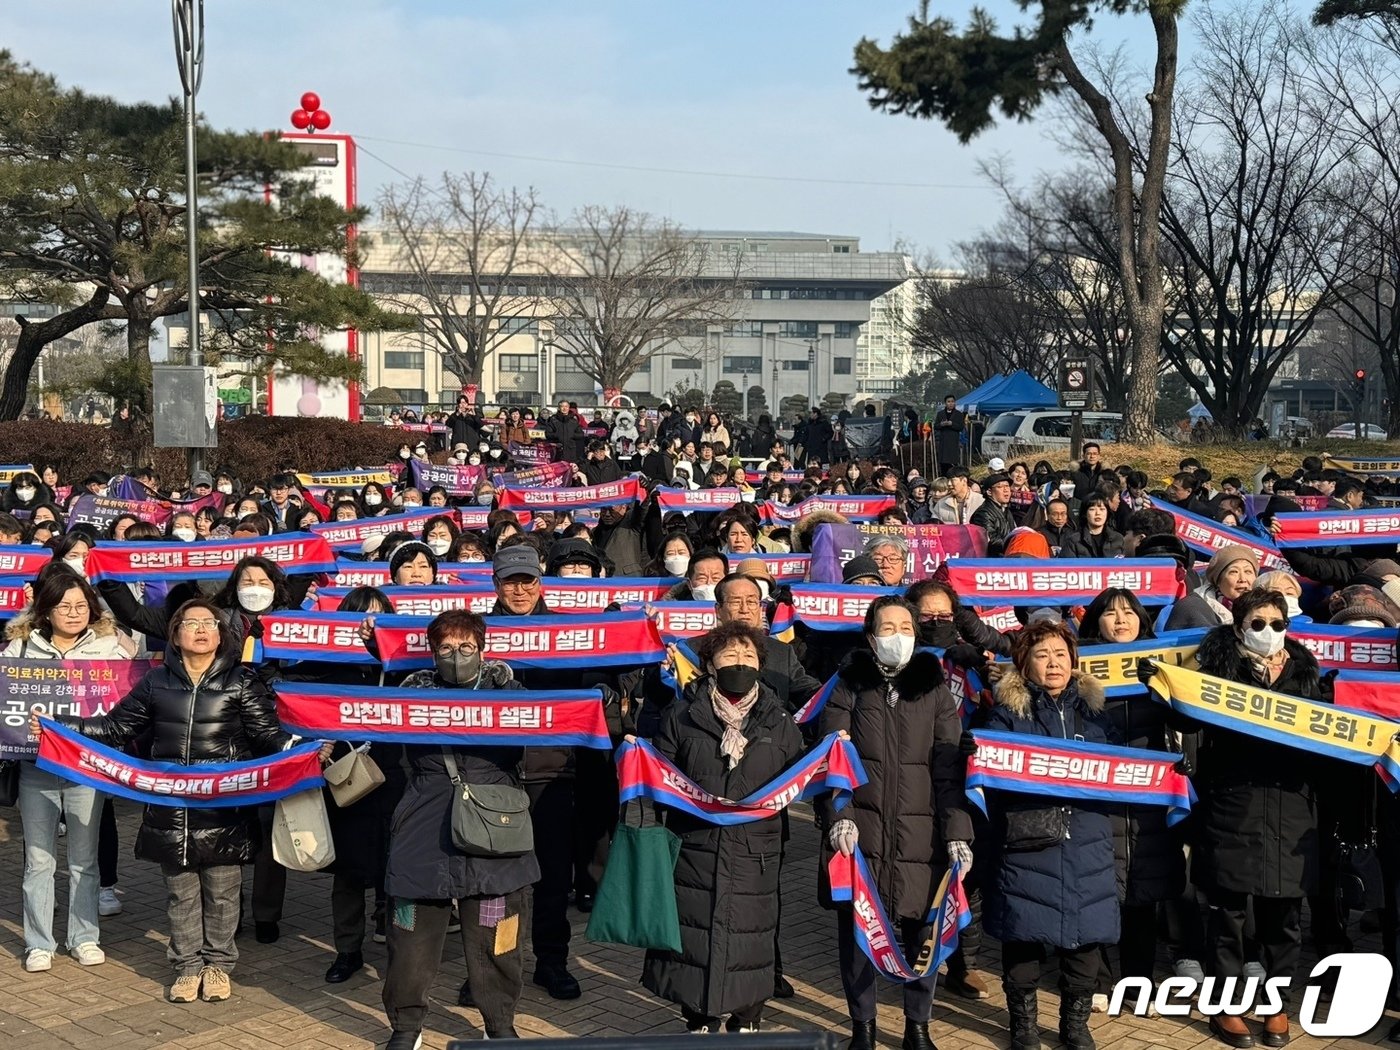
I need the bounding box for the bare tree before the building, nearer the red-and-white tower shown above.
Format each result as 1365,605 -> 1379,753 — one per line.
379,171 -> 539,386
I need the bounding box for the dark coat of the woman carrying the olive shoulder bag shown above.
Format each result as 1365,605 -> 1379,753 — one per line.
385,659 -> 539,900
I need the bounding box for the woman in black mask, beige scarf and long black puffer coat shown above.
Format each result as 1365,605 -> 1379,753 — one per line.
641,623 -> 802,1033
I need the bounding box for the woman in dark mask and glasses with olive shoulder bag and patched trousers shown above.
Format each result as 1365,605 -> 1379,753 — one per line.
384,613 -> 537,1050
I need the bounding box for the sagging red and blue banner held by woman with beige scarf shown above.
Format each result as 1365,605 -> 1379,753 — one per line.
616,732 -> 867,826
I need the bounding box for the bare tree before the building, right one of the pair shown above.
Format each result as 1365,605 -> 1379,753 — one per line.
540,206 -> 742,391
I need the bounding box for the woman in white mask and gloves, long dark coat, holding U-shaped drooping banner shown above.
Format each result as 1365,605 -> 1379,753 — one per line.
816,595 -> 973,1050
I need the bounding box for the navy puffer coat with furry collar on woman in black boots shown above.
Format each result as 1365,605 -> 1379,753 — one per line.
981,671 -> 1119,948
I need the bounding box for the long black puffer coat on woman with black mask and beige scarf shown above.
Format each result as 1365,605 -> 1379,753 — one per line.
641,675 -> 802,1016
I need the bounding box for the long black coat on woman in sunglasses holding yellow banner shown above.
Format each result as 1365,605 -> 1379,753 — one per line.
1191,624 -> 1327,897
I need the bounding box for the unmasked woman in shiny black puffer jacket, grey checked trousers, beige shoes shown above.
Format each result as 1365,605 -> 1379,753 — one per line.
47,598 -> 306,1002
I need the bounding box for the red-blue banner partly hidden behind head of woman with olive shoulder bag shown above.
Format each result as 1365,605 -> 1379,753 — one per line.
374,612 -> 666,671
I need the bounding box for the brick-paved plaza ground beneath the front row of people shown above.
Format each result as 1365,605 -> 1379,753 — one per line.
0,801 -> 1389,1050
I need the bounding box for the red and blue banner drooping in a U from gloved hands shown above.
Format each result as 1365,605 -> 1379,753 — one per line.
826,846 -> 972,983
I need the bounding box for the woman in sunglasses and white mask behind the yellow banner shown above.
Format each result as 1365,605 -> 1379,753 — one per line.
1191,589 -> 1331,1047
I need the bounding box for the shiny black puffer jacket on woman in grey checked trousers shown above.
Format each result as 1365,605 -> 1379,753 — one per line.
60,648 -> 291,868
